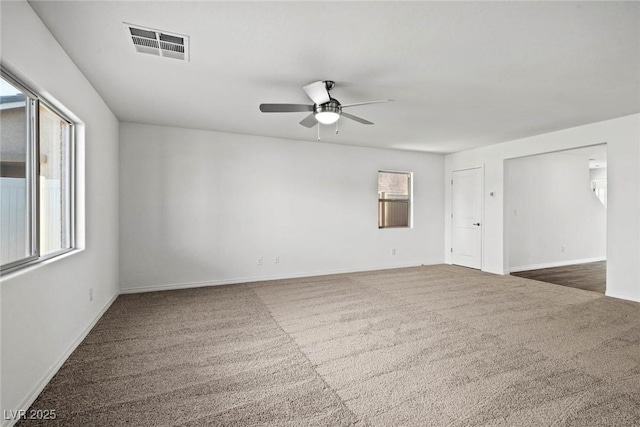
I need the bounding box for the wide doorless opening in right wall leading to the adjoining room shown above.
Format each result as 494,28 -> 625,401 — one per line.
505,144 -> 607,293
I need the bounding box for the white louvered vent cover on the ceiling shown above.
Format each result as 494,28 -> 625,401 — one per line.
124,22 -> 189,61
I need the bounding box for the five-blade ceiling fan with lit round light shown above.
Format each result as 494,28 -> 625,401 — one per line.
260,80 -> 393,128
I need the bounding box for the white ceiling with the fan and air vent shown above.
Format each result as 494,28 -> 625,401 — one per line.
30,1 -> 640,153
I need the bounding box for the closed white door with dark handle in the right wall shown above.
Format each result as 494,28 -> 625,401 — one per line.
451,168 -> 483,269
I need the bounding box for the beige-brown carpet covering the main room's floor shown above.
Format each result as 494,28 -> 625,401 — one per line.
21,266 -> 640,426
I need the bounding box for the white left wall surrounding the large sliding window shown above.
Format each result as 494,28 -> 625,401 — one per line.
0,1 -> 118,424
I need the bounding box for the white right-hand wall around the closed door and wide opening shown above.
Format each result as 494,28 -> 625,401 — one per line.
445,114 -> 640,300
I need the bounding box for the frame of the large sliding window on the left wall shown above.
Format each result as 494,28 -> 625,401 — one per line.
0,64 -> 77,276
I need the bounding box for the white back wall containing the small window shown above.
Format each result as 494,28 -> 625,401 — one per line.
120,123 -> 444,292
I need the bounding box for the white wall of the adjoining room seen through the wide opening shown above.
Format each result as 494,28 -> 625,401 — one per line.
505,151 -> 607,271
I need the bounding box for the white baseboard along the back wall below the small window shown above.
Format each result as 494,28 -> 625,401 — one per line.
120,260 -> 442,294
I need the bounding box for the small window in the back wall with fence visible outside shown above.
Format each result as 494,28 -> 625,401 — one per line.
378,171 -> 411,228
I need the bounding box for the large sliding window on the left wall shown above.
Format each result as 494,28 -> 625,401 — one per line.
0,70 -> 74,271
